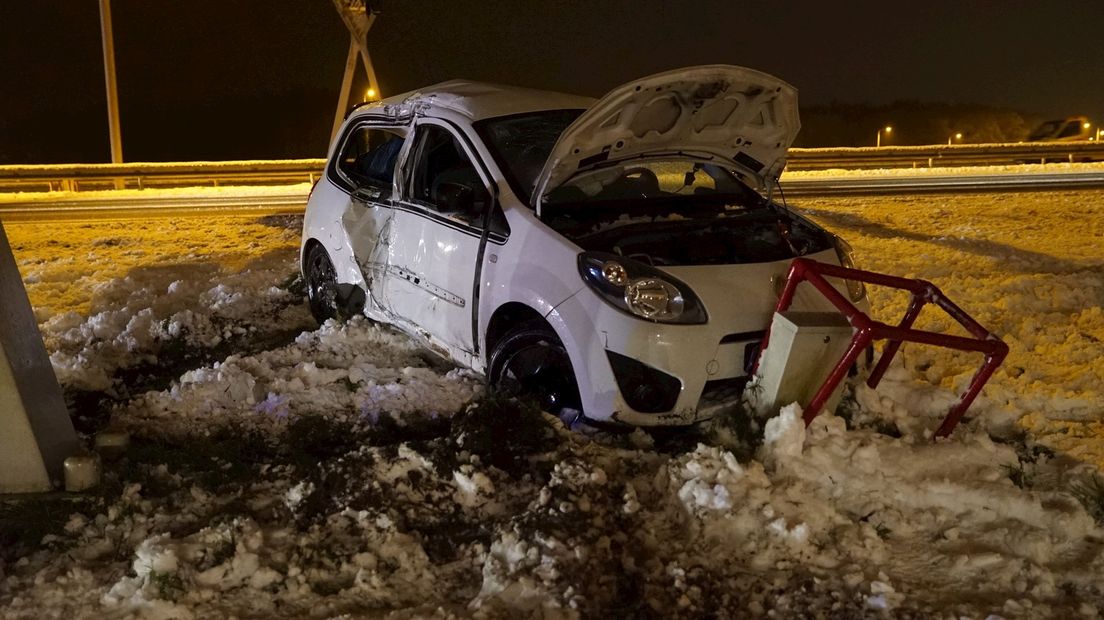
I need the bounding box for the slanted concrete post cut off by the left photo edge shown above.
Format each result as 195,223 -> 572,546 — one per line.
0,219 -> 81,493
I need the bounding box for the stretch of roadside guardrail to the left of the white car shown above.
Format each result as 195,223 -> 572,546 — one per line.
0,159 -> 326,192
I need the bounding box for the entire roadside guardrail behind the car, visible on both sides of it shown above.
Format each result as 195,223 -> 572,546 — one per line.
0,142 -> 1104,192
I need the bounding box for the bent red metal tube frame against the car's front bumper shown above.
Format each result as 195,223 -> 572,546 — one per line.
762,258 -> 1008,437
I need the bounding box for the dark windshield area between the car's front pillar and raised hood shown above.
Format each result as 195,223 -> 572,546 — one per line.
474,109 -> 584,204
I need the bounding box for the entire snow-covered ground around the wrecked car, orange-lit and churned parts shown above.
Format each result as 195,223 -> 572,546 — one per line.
0,185 -> 1104,619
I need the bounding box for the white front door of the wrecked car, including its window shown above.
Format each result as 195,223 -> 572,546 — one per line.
384,118 -> 493,361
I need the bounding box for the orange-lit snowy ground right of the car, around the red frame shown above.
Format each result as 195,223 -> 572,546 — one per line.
795,191 -> 1104,467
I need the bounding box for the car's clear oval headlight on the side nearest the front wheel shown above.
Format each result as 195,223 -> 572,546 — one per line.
578,252 -> 709,324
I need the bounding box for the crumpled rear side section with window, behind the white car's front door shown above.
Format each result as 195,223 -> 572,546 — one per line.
329,117 -> 408,312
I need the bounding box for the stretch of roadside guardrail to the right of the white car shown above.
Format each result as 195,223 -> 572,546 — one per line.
786,142 -> 1104,170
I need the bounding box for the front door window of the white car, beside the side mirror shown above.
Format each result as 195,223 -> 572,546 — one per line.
410,125 -> 491,226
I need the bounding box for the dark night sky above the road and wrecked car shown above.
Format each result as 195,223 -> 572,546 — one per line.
0,0 -> 1104,163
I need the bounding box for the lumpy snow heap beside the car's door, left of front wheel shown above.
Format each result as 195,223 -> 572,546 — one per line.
115,319 -> 482,435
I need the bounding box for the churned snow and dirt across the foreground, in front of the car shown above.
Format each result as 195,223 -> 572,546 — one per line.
0,407 -> 1104,618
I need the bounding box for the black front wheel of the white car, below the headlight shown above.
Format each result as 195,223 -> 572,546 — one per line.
487,321 -> 582,416
